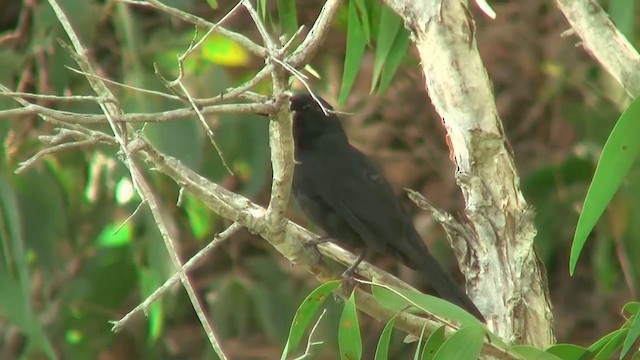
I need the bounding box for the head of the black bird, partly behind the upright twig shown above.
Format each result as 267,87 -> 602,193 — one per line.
291,94 -> 347,149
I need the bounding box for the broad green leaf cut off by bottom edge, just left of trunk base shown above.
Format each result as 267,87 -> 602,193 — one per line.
433,325 -> 485,360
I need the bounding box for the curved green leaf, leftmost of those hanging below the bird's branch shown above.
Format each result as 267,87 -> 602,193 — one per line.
280,280 -> 341,360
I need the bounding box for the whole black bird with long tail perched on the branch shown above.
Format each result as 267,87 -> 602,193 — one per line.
291,94 -> 484,321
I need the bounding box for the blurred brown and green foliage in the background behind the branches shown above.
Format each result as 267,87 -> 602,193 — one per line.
0,0 -> 640,359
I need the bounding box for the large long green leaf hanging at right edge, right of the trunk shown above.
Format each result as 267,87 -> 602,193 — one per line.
569,98 -> 640,275
